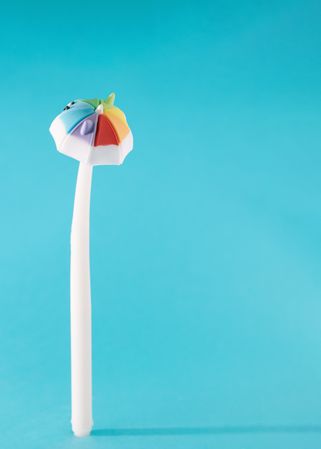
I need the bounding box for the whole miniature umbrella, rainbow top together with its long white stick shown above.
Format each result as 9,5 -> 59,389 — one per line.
49,94 -> 133,437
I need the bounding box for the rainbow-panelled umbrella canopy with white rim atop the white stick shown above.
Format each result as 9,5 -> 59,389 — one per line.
50,94 -> 133,165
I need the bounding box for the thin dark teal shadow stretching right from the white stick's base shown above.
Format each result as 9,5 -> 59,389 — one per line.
91,425 -> 321,437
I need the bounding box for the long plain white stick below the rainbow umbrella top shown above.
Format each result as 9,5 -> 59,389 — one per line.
70,162 -> 93,437
